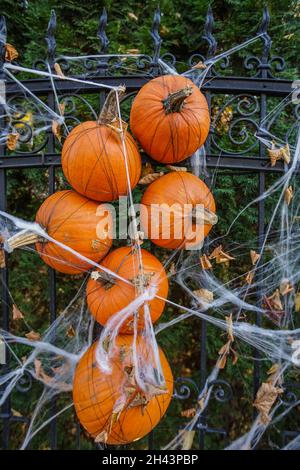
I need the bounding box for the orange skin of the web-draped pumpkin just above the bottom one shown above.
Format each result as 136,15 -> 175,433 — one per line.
86,247 -> 169,334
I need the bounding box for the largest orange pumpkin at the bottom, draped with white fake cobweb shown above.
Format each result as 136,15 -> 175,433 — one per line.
73,335 -> 173,445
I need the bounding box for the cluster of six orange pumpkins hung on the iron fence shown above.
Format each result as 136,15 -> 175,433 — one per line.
9,75 -> 215,444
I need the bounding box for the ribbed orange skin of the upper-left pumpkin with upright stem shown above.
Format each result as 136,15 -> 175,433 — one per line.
62,121 -> 141,202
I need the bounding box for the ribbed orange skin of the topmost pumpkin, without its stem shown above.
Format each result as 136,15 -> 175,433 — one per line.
130,75 -> 210,163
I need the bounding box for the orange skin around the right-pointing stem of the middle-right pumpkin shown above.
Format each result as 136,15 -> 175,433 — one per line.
141,171 -> 216,249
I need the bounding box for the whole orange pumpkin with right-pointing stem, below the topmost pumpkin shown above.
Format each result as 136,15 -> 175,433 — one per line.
141,171 -> 217,249
